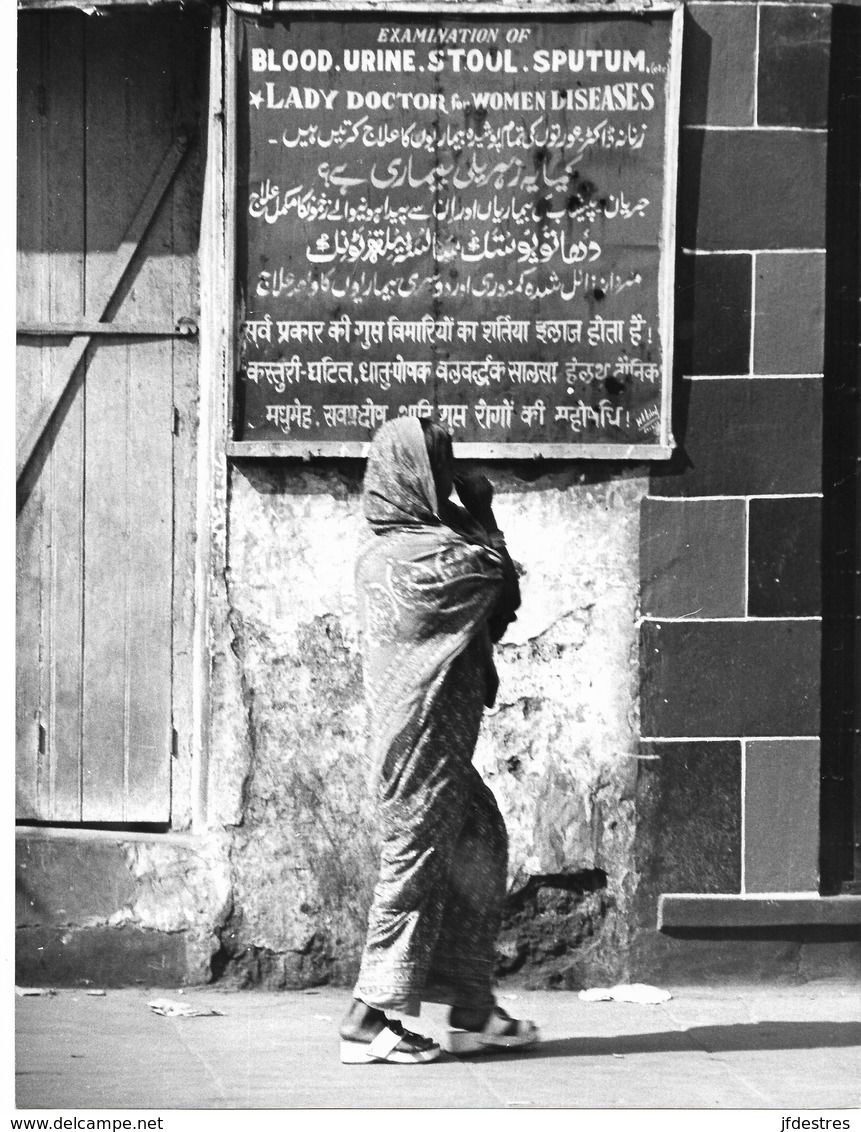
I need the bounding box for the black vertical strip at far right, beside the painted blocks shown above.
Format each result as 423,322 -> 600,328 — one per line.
820,5 -> 861,893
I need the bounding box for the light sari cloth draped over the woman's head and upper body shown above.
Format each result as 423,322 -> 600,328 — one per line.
356,417 -> 503,784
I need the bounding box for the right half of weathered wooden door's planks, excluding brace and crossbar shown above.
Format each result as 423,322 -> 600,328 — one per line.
84,16 -> 173,822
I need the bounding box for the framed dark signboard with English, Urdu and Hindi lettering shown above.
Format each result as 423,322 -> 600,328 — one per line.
230,5 -> 679,460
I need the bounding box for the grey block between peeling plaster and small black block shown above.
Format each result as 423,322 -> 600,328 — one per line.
640,498 -> 744,617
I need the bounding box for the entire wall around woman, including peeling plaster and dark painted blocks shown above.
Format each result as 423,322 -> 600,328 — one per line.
18,0 -> 861,987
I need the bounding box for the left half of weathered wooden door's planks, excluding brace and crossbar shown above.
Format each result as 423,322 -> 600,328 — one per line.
17,12 -> 84,821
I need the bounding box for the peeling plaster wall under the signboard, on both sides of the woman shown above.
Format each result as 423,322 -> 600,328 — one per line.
210,462 -> 647,986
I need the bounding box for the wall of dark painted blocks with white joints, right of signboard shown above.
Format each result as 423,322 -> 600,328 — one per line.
635,2 -> 859,975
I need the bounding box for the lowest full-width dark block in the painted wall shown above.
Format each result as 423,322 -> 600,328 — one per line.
640,621 -> 820,738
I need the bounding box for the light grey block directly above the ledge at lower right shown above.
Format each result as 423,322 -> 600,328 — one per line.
744,739 -> 819,899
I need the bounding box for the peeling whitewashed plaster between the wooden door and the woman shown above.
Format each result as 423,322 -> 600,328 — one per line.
212,464 -> 373,985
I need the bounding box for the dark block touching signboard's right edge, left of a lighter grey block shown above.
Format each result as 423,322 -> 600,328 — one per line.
675,255 -> 752,376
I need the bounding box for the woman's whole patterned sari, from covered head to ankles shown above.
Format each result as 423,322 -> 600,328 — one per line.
355,418 -> 516,1014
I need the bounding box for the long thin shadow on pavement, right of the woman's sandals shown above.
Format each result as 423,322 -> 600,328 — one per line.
459,1022 -> 861,1062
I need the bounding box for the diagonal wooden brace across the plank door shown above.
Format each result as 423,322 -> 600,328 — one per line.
16,137 -> 190,482
